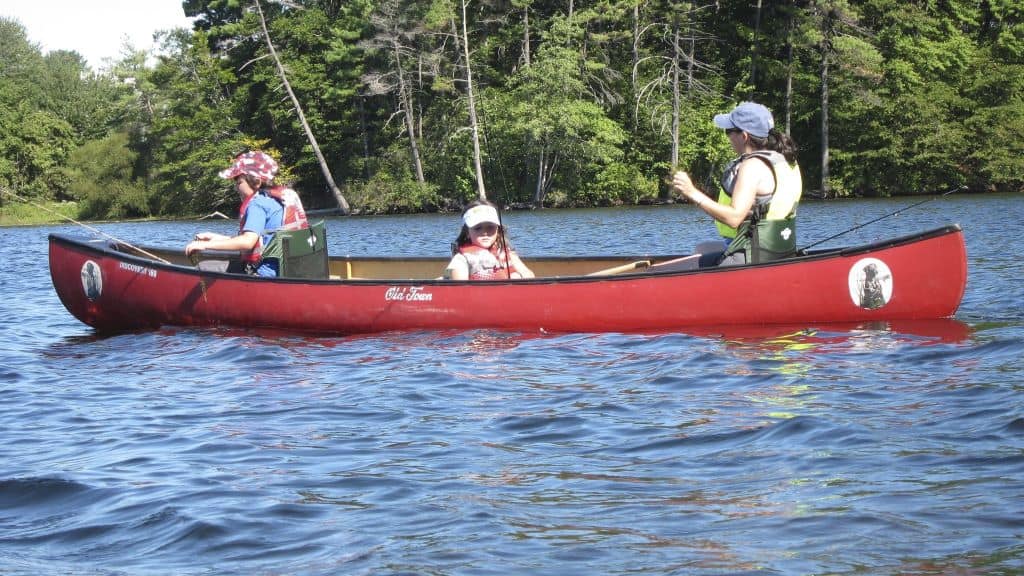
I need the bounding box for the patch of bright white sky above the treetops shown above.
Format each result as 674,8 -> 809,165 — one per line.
0,0 -> 190,71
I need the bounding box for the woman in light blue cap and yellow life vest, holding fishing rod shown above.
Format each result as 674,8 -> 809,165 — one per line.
672,102 -> 803,268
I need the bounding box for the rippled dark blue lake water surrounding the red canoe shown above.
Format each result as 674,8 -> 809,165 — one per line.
0,196 -> 1024,576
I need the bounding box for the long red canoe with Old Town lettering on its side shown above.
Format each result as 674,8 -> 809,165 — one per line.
49,224 -> 967,334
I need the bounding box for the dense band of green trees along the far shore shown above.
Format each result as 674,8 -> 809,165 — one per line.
0,0 -> 1024,217
